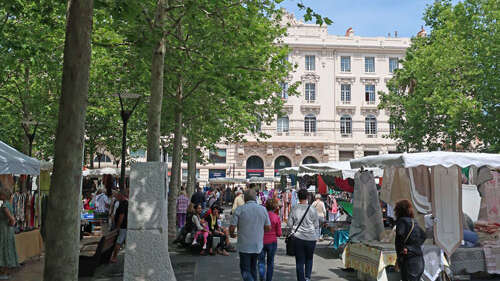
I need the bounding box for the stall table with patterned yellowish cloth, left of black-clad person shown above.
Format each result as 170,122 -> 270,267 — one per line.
343,241 -> 397,281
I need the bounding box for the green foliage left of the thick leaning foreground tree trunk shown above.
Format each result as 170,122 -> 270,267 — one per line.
0,1 -> 66,158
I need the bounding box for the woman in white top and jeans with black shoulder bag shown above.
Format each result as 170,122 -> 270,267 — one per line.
287,189 -> 319,281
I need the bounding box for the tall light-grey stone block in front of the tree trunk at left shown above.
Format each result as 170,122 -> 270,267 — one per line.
123,162 -> 176,281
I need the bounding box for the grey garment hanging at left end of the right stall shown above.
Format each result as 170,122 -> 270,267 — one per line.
349,171 -> 384,242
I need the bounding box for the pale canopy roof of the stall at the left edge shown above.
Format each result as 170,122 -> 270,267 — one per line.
0,141 -> 40,176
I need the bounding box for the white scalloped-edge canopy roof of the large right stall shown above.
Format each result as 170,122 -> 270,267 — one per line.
351,151 -> 500,168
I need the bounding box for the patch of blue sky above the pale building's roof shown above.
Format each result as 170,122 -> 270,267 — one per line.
281,0 -> 444,37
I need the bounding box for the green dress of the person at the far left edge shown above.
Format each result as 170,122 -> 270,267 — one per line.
0,201 -> 19,267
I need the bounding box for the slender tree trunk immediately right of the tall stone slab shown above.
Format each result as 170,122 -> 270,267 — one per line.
168,79 -> 183,235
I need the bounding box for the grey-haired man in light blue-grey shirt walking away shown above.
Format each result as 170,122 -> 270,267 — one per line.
229,189 -> 271,281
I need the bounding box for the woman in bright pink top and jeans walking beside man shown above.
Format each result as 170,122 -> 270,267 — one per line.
258,199 -> 281,281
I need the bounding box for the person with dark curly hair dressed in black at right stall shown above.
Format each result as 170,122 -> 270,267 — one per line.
394,200 -> 426,281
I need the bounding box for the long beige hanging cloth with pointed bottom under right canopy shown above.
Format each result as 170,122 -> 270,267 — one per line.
432,166 -> 463,256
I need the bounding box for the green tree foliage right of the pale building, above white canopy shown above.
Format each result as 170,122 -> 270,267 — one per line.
380,0 -> 500,152
